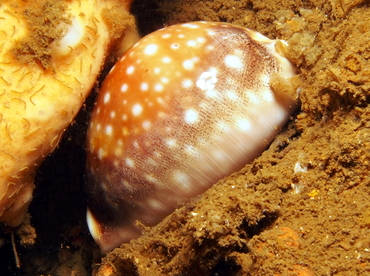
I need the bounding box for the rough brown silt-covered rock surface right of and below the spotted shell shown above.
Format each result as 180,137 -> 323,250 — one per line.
98,1 -> 370,275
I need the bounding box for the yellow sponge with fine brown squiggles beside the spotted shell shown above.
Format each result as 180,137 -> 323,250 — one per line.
0,0 -> 135,226
